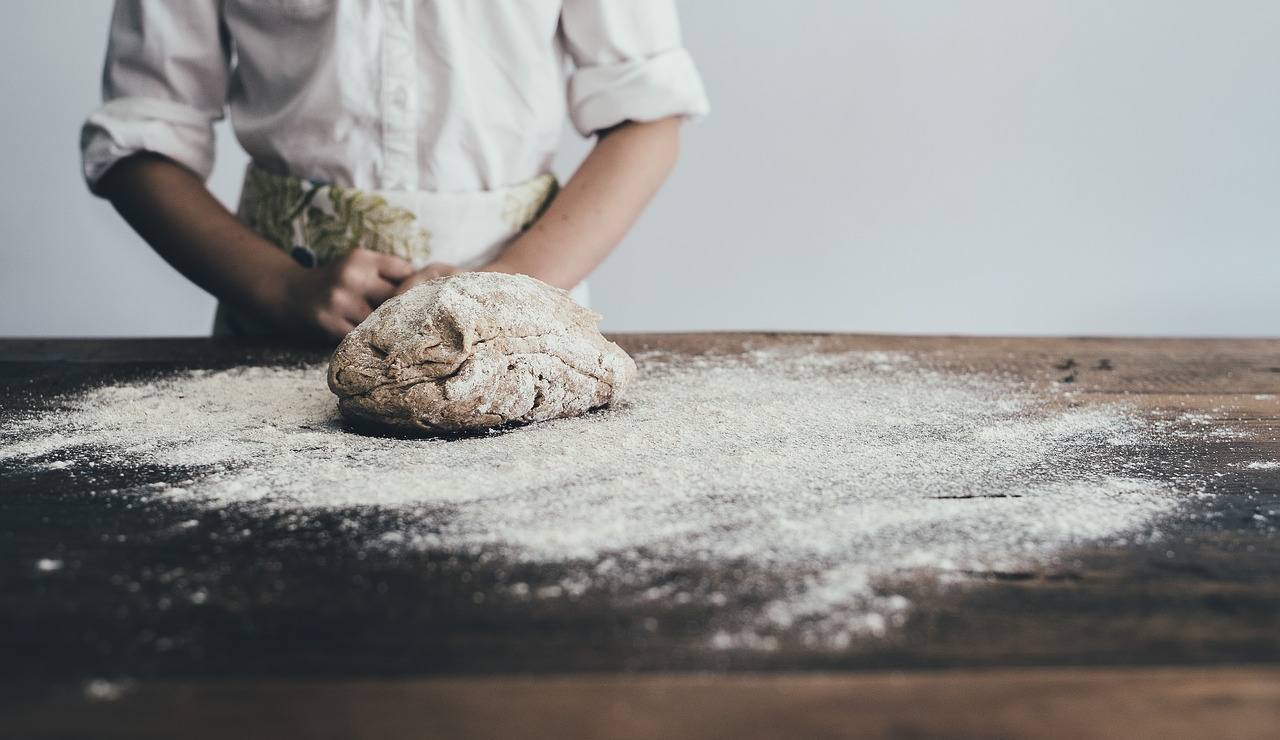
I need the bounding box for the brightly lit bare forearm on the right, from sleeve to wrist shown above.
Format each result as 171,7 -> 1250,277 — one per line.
485,118 -> 681,289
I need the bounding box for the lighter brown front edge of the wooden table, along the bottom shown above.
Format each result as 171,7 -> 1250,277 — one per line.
8,668 -> 1280,740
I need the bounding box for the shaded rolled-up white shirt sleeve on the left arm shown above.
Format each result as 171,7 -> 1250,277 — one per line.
81,0 -> 230,191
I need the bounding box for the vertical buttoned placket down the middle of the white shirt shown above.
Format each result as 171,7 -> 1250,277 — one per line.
381,0 -> 417,189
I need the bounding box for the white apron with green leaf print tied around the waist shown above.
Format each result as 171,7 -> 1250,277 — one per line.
214,164 -> 588,337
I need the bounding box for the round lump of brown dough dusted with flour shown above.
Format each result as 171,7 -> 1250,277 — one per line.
329,273 -> 636,431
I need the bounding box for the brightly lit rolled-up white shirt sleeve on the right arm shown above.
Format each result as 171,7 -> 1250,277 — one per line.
561,0 -> 709,136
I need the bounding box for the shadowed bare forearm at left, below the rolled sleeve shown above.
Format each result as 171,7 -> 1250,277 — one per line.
99,154 -> 300,314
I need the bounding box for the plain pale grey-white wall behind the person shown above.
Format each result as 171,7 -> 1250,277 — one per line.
0,0 -> 1280,335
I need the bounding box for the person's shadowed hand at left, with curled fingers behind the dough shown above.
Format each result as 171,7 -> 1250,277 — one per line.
264,248 -> 413,339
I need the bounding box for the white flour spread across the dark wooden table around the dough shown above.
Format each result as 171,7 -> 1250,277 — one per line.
0,351 -> 1179,649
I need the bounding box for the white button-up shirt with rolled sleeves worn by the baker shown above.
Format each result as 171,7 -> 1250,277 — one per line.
81,0 -> 708,192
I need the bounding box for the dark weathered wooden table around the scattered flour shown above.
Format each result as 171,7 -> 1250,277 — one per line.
0,334 -> 1280,739
